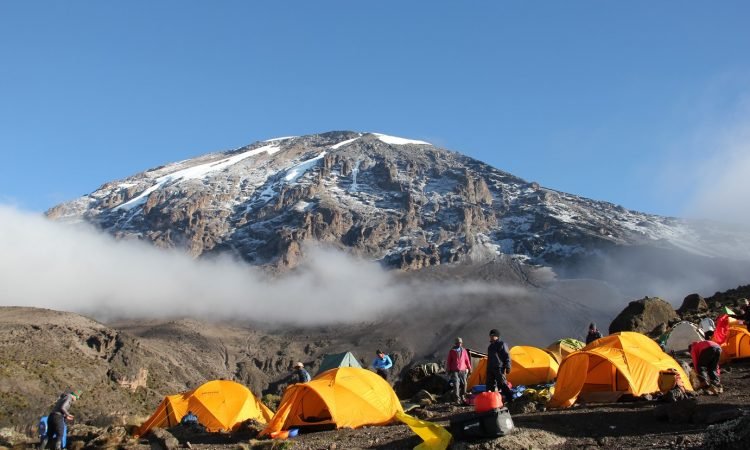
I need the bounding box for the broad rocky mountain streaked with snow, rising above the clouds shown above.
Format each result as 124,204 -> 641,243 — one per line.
47,131 -> 750,269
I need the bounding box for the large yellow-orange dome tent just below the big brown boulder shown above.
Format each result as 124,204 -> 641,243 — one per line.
548,331 -> 693,408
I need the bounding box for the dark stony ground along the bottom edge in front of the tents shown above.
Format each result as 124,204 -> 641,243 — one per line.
0,361 -> 750,450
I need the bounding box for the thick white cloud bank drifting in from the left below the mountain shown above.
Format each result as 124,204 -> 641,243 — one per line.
0,206 -> 525,325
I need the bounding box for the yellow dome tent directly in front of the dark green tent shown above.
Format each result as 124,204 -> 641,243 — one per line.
262,367 -> 404,435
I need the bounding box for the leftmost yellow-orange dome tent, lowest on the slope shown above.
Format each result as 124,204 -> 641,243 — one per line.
136,380 -> 273,436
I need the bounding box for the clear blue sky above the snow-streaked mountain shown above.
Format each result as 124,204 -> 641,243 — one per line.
0,0 -> 750,215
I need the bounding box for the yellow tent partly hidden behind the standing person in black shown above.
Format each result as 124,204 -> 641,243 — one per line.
466,345 -> 558,388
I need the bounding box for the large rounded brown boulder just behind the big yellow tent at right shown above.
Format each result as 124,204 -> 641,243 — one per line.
609,297 -> 680,334
